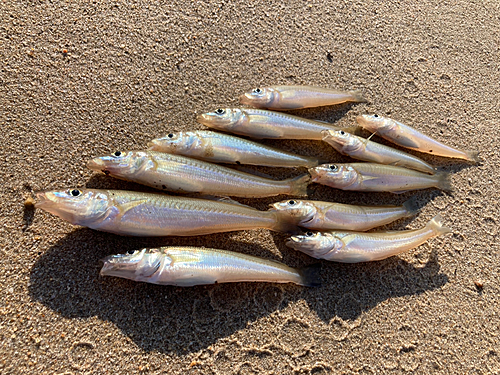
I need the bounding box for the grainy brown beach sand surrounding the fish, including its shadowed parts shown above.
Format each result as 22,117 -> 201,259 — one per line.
0,0 -> 500,374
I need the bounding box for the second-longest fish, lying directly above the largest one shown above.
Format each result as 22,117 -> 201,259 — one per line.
87,151 -> 311,198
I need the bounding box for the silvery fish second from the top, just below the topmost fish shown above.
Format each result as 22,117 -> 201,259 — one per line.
197,108 -> 353,140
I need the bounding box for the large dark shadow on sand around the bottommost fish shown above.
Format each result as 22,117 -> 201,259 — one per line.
29,229 -> 448,354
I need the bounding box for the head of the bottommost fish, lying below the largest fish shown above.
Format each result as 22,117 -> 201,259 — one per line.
101,248 -> 164,281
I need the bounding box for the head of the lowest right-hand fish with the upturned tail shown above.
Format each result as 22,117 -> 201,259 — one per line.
286,231 -> 344,259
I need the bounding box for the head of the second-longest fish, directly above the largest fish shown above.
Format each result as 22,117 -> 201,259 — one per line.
87,151 -> 150,177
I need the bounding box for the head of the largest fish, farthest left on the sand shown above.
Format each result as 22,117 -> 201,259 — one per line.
35,189 -> 110,225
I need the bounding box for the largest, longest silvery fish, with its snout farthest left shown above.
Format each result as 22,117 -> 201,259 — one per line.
35,189 -> 296,237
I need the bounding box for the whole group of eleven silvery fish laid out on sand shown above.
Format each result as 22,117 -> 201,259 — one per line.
36,86 -> 478,286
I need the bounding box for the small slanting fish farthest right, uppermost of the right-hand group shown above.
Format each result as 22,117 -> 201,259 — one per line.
356,115 -> 480,162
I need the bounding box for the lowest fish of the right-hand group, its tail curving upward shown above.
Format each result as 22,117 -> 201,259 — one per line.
286,215 -> 451,263
